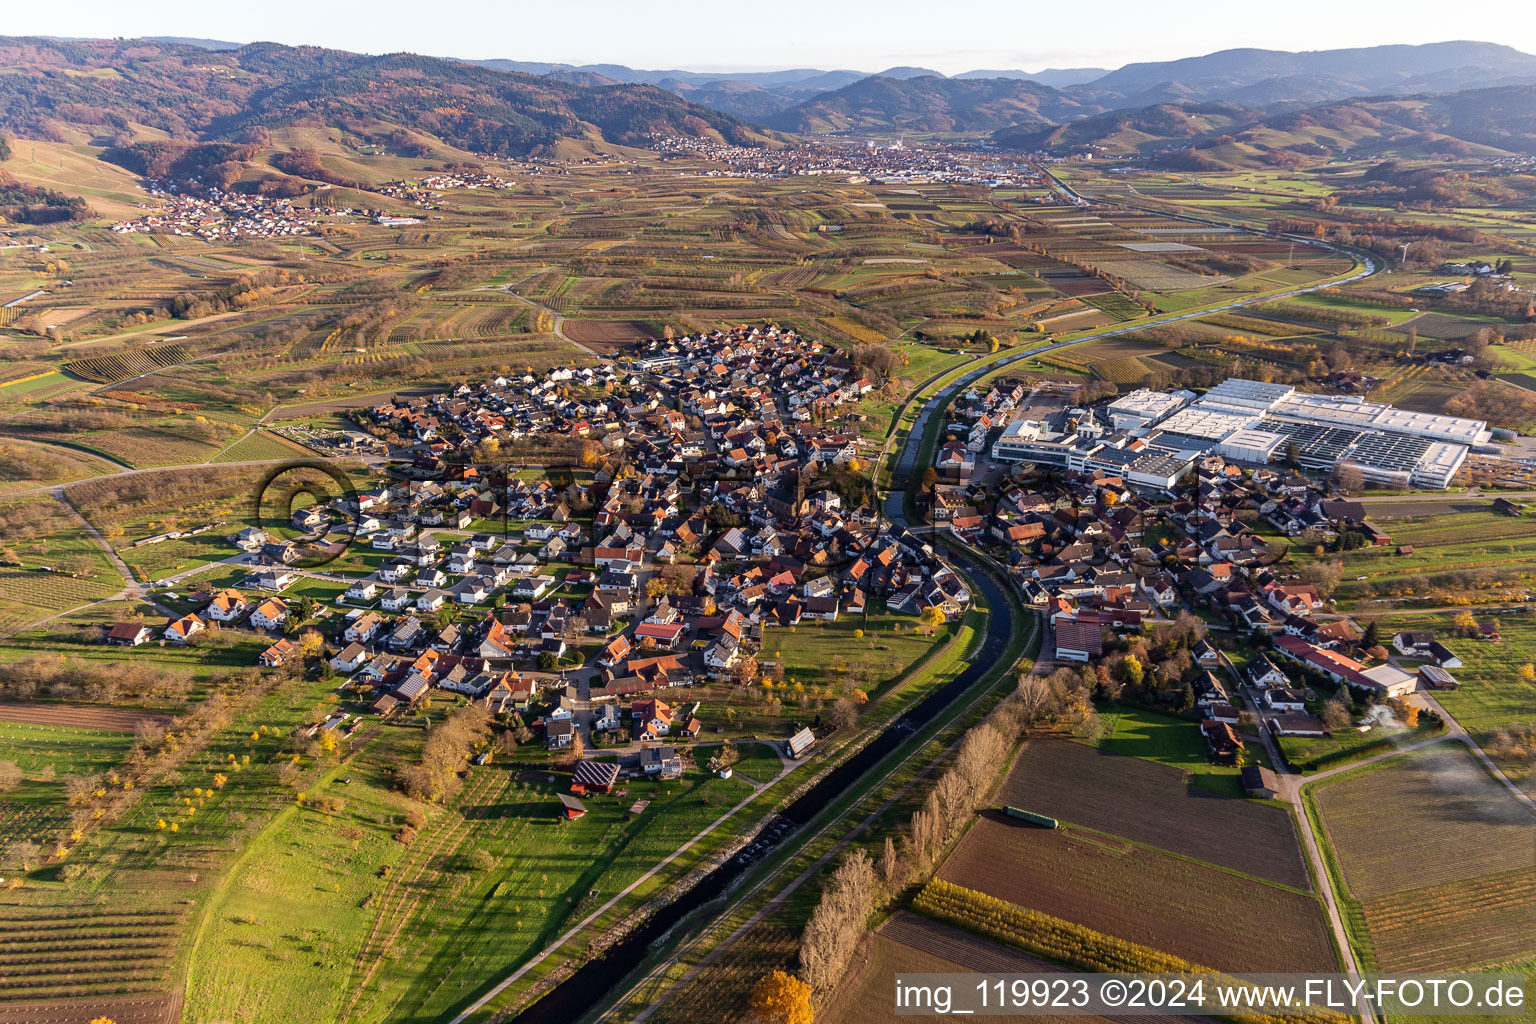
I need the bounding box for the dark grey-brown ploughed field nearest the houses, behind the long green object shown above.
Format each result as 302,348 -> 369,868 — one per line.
998,738 -> 1310,889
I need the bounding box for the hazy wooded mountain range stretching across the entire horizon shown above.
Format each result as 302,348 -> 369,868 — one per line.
0,37 -> 1536,169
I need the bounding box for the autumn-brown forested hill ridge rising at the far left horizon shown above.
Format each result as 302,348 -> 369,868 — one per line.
0,37 -> 762,155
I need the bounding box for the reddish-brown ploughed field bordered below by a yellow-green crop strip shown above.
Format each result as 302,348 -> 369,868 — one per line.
938,812 -> 1335,972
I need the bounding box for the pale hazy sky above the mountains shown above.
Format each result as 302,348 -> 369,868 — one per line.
21,0 -> 1536,74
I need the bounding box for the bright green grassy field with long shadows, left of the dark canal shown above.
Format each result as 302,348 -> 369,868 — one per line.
187,726 -> 768,1019
